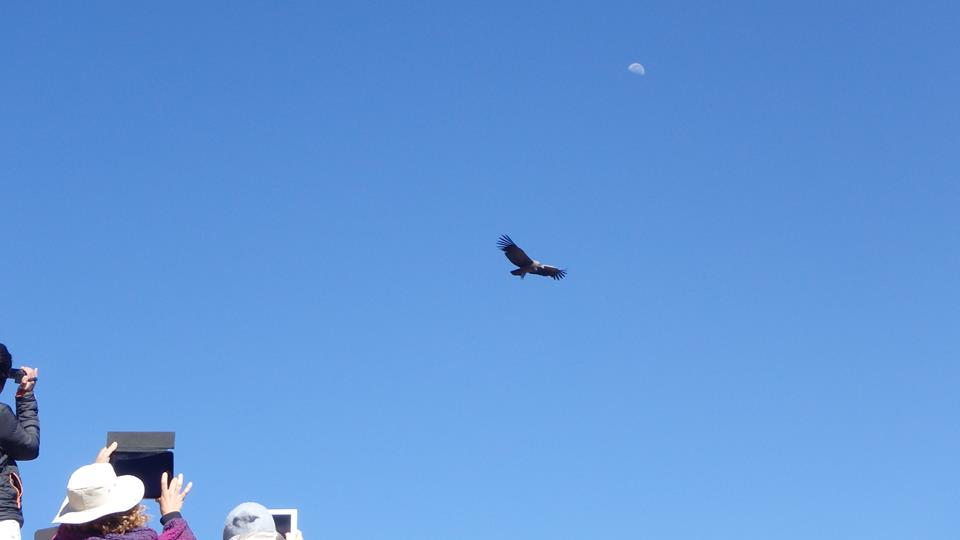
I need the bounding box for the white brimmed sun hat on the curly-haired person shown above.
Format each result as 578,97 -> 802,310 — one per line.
53,463 -> 143,524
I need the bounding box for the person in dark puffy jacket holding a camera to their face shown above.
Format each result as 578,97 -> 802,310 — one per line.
0,343 -> 40,540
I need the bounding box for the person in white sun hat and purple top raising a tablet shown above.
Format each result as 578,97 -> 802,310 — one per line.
53,443 -> 196,540
